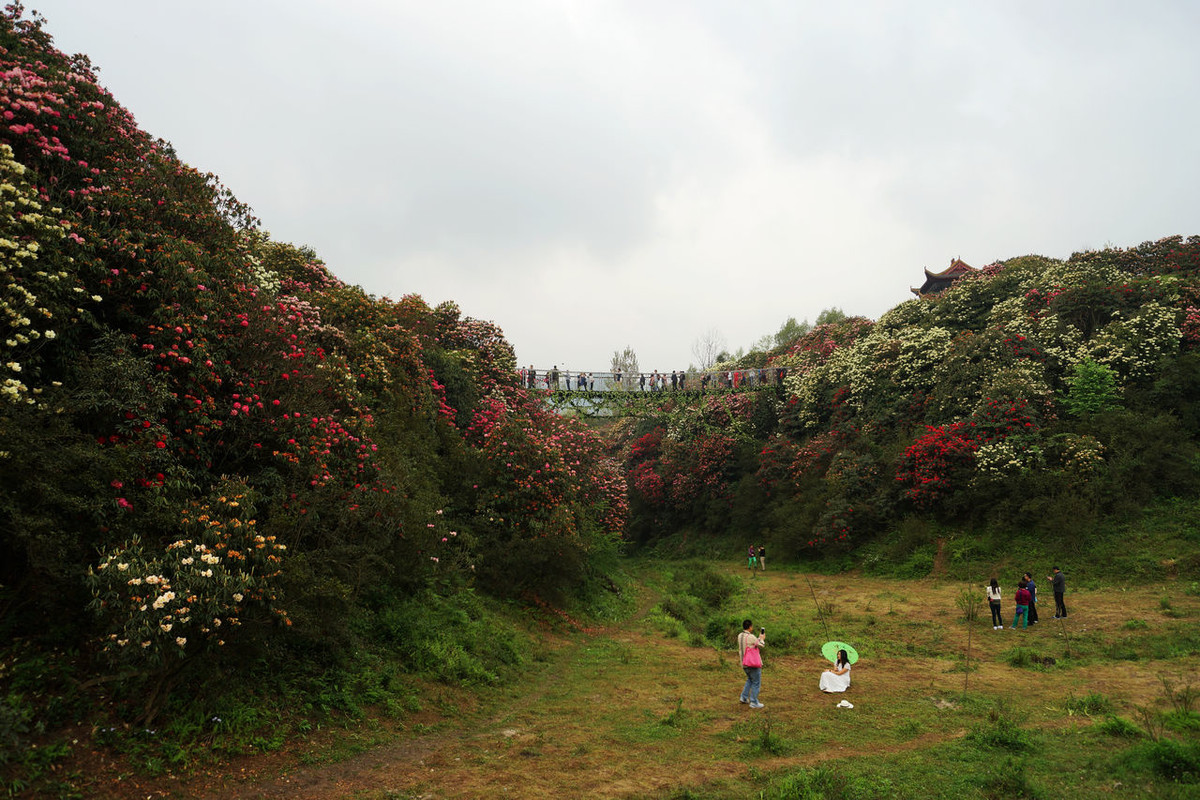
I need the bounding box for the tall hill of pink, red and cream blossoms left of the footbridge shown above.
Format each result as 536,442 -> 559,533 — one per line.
0,5 -> 625,709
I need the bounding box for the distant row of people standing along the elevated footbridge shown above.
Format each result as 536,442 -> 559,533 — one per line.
518,365 -> 787,392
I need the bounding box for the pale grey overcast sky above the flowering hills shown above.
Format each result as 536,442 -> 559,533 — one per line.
26,0 -> 1200,372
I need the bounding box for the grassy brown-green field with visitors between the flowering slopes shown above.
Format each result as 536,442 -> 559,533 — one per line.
114,561 -> 1200,800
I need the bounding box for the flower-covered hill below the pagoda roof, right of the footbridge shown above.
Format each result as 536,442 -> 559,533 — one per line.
626,236 -> 1200,575
